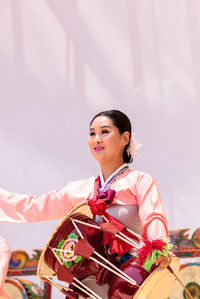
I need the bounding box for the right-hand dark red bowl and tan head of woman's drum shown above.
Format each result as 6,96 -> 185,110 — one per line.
108,257 -> 179,299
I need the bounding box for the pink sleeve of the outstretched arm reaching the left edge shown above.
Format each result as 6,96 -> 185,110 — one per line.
0,182 -> 88,223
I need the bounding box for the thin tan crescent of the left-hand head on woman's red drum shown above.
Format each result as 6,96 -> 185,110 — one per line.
37,202 -> 93,280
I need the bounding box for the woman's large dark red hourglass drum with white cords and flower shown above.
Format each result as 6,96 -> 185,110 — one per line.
37,203 -> 179,299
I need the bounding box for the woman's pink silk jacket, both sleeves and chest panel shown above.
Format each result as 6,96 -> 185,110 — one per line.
0,170 -> 168,239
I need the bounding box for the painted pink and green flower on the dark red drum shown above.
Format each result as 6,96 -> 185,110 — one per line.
56,233 -> 83,268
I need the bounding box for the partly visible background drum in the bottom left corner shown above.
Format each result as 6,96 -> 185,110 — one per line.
3,278 -> 45,299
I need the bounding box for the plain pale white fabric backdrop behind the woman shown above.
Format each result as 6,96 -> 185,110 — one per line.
0,0 -> 200,298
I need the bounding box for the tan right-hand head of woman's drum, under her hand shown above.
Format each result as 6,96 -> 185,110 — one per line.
134,257 -> 181,299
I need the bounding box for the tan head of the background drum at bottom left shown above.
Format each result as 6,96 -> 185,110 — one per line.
3,278 -> 28,299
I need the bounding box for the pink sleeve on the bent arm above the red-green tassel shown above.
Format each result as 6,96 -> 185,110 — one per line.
136,173 -> 169,240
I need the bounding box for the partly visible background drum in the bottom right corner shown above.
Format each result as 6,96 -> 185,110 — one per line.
169,259 -> 200,299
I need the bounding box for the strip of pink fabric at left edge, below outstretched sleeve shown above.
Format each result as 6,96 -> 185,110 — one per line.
0,236 -> 11,299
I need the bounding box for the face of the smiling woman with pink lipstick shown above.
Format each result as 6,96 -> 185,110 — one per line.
88,116 -> 129,163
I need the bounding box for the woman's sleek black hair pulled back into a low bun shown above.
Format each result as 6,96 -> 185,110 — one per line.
90,110 -> 133,163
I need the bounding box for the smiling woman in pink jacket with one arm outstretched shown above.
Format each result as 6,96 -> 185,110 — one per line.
0,110 -> 171,296
